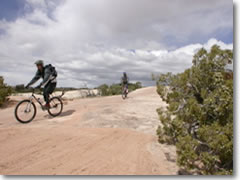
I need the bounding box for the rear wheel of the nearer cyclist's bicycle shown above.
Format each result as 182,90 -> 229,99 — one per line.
48,97 -> 63,117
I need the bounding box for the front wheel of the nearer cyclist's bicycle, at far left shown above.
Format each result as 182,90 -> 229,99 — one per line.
14,100 -> 37,123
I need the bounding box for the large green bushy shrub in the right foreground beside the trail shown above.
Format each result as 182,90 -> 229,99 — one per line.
157,45 -> 233,175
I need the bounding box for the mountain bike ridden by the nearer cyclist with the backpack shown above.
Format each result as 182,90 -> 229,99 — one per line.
15,89 -> 64,123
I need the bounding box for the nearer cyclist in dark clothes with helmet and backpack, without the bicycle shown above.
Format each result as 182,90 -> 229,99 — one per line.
26,60 -> 57,109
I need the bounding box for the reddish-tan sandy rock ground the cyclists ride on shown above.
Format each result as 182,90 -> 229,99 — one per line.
0,87 -> 178,175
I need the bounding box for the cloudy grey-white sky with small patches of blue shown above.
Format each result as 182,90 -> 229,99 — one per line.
0,0 -> 233,87
